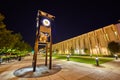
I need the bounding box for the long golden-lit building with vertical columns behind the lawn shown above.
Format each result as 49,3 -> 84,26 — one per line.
53,23 -> 120,55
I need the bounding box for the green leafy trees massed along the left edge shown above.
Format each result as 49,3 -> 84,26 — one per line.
0,13 -> 32,55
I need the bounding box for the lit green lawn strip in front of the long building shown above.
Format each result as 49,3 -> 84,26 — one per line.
53,55 -> 113,64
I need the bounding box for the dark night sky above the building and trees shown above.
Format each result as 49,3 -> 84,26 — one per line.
0,0 -> 120,46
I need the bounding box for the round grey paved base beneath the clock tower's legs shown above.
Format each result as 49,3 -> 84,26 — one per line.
14,64 -> 61,78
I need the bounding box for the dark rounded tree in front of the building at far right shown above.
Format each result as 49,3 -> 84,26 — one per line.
108,41 -> 120,54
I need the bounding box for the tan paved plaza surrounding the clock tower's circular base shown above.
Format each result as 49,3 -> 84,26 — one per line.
0,56 -> 120,80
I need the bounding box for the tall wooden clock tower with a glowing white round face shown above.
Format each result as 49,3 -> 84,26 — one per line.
32,10 -> 55,72
